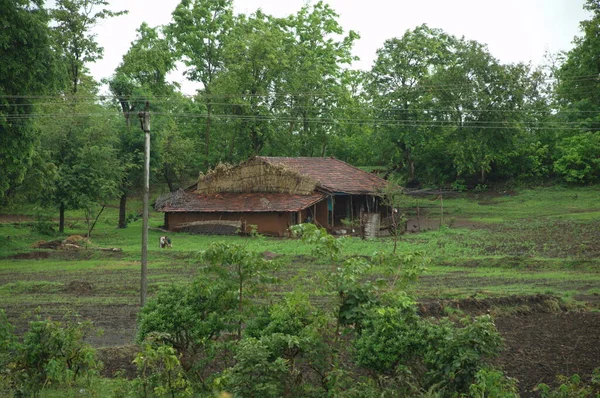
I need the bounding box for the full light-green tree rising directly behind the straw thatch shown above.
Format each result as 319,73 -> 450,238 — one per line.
213,10 -> 289,162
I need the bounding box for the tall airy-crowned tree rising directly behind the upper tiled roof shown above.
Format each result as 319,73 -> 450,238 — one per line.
279,1 -> 359,156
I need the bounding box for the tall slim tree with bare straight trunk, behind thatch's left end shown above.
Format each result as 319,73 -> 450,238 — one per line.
167,0 -> 233,168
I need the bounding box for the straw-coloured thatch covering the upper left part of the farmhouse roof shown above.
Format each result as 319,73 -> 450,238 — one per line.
196,158 -> 317,195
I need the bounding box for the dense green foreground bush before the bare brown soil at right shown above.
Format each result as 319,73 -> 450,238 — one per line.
354,304 -> 501,393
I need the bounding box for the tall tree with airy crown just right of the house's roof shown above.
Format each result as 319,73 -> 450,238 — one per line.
369,25 -> 456,181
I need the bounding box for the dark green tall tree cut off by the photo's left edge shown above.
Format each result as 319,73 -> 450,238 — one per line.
0,0 -> 60,201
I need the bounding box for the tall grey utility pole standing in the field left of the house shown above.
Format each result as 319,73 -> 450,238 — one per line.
138,101 -> 150,307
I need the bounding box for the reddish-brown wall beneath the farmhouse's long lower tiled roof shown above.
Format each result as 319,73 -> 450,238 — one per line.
165,212 -> 291,236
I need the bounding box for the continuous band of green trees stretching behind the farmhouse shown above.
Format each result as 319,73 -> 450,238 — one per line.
0,0 -> 600,230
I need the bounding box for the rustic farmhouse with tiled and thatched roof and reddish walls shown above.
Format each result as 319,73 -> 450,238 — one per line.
155,156 -> 388,236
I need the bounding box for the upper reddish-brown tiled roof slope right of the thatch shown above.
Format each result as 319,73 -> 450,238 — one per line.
259,156 -> 387,195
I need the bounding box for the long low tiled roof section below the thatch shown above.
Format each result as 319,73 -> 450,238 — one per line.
156,191 -> 326,213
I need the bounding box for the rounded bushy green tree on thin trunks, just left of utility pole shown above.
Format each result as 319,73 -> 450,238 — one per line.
38,91 -> 123,233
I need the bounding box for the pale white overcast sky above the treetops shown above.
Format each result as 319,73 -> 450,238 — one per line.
89,0 -> 590,94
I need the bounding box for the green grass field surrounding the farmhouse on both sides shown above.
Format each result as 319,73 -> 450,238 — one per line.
0,187 -> 600,320
